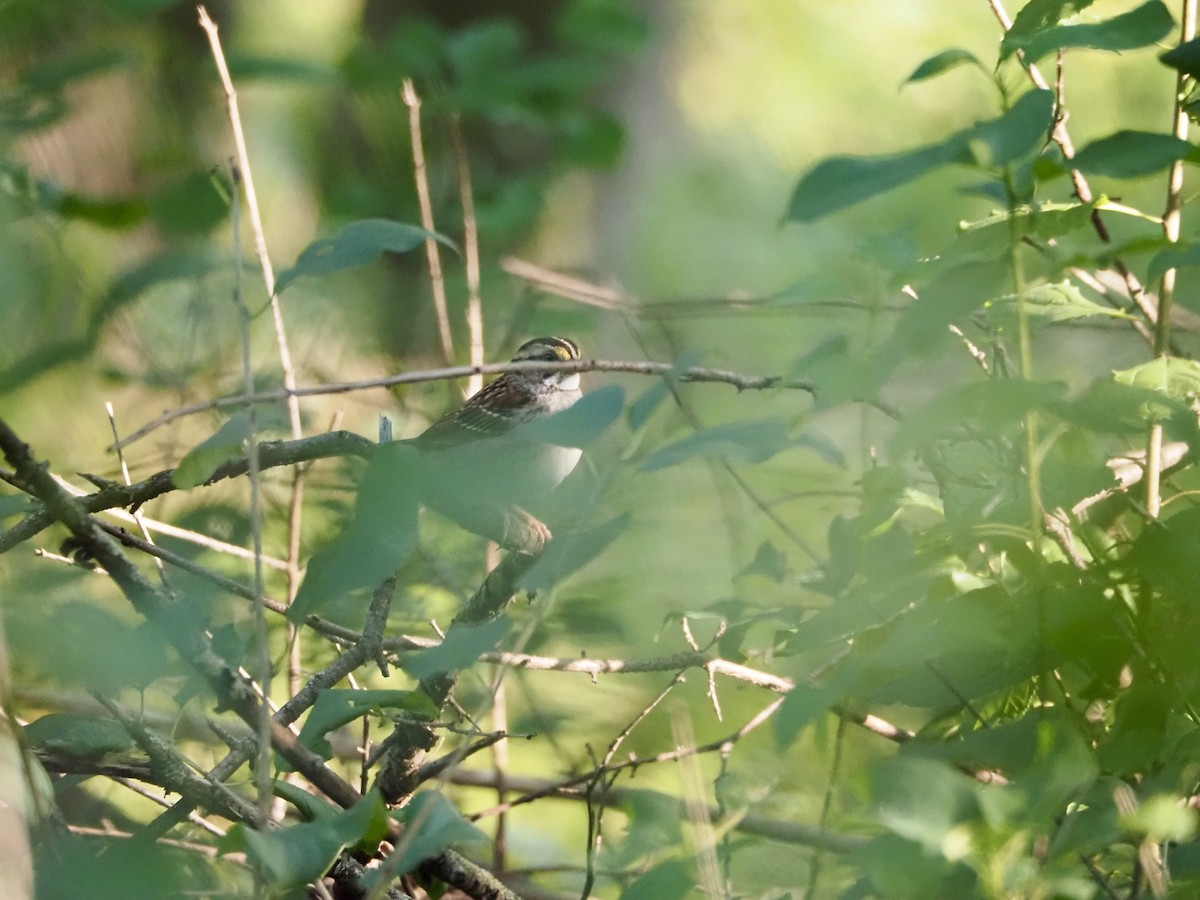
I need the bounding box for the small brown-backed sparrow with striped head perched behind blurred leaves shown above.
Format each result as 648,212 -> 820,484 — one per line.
412,337 -> 582,553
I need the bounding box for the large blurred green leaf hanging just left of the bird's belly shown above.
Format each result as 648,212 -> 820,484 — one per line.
288,442 -> 419,622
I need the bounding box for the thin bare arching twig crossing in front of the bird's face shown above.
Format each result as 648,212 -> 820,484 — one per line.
112,360 -> 816,446
